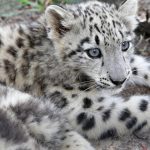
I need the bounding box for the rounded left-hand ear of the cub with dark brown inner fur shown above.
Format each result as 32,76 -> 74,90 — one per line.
45,5 -> 74,37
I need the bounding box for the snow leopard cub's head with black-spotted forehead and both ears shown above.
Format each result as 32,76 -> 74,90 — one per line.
45,0 -> 138,92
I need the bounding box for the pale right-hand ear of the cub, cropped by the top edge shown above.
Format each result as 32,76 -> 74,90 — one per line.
119,0 -> 138,30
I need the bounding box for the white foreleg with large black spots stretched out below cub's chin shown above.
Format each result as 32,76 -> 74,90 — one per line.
68,95 -> 150,140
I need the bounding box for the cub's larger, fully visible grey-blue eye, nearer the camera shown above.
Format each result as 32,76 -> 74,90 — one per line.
86,48 -> 102,59
